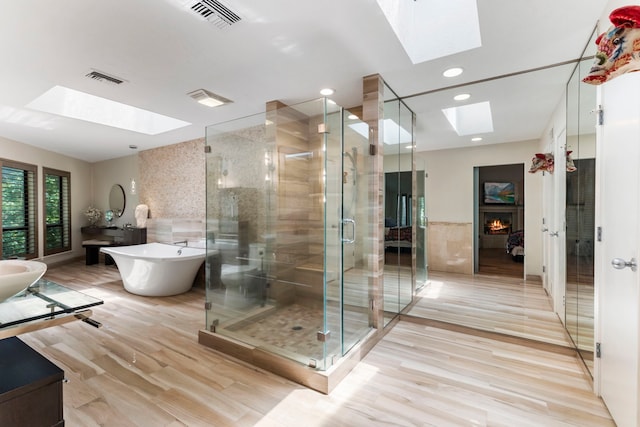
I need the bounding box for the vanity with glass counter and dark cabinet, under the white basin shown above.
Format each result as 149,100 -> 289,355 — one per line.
0,279 -> 103,427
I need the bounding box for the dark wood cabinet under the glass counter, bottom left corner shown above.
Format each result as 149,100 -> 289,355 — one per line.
0,337 -> 64,427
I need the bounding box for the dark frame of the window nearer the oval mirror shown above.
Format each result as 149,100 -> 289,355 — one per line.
42,166 -> 72,256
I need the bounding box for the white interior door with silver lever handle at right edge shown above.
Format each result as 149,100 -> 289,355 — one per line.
595,73 -> 640,427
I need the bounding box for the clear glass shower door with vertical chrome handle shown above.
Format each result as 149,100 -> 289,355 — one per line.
323,106 -> 370,365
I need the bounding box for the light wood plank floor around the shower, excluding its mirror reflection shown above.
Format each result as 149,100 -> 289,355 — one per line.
15,262 -> 614,427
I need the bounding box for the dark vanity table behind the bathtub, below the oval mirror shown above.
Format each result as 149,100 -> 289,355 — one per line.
80,227 -> 147,265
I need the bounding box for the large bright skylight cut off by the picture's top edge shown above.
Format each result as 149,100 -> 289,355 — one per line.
377,0 -> 482,64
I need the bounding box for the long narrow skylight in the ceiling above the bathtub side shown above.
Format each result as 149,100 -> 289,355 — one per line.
27,86 -> 191,135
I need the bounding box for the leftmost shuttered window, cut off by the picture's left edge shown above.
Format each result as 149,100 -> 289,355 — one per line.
0,159 -> 38,259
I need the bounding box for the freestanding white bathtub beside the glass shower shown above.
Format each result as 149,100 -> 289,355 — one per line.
100,243 -> 206,297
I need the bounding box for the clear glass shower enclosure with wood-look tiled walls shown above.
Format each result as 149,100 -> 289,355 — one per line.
205,98 -> 374,371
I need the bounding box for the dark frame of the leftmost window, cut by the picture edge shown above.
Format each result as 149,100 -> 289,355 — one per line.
0,158 -> 39,259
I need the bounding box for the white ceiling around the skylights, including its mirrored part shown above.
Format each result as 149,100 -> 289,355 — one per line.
0,0 -> 609,162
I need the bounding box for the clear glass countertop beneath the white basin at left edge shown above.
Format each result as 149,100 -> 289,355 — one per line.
0,279 -> 104,331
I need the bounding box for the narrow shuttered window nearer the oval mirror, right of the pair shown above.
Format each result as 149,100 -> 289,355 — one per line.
42,168 -> 71,255
